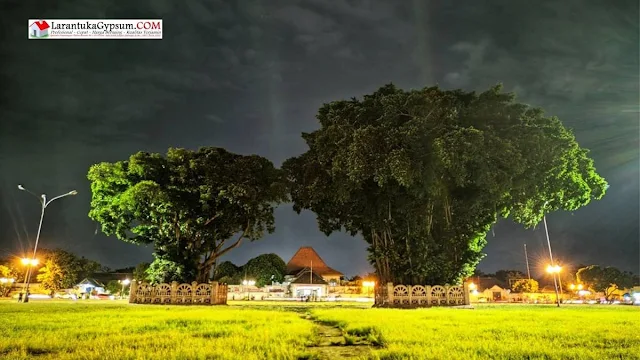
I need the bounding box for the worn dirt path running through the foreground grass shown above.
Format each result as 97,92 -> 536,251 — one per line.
303,315 -> 372,360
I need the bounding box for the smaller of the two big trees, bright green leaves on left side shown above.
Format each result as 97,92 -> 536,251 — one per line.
88,147 -> 287,281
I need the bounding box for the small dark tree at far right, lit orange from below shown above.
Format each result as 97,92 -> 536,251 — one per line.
576,265 -> 634,300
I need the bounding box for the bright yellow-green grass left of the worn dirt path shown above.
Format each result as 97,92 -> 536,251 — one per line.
0,301 -> 313,360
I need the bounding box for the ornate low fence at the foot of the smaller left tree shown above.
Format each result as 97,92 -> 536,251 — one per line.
129,280 -> 227,305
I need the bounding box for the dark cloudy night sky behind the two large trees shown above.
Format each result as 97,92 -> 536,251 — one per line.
0,0 -> 640,275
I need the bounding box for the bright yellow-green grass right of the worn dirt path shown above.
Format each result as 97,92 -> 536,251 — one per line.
313,304 -> 640,360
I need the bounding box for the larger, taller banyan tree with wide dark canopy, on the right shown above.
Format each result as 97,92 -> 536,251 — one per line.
283,85 -> 607,284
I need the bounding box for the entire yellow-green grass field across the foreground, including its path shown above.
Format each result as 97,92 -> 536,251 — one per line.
0,301 -> 640,360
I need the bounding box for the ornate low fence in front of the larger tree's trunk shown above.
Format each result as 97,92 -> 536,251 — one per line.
375,283 -> 471,307
